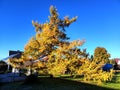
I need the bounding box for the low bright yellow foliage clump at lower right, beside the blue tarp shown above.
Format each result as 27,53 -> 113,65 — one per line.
77,60 -> 113,84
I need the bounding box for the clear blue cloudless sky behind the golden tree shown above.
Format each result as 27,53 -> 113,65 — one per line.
0,0 -> 120,59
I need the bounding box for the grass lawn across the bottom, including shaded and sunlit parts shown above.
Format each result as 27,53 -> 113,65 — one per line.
0,73 -> 120,90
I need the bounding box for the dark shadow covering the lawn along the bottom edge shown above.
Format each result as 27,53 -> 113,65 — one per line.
0,77 -> 114,90
